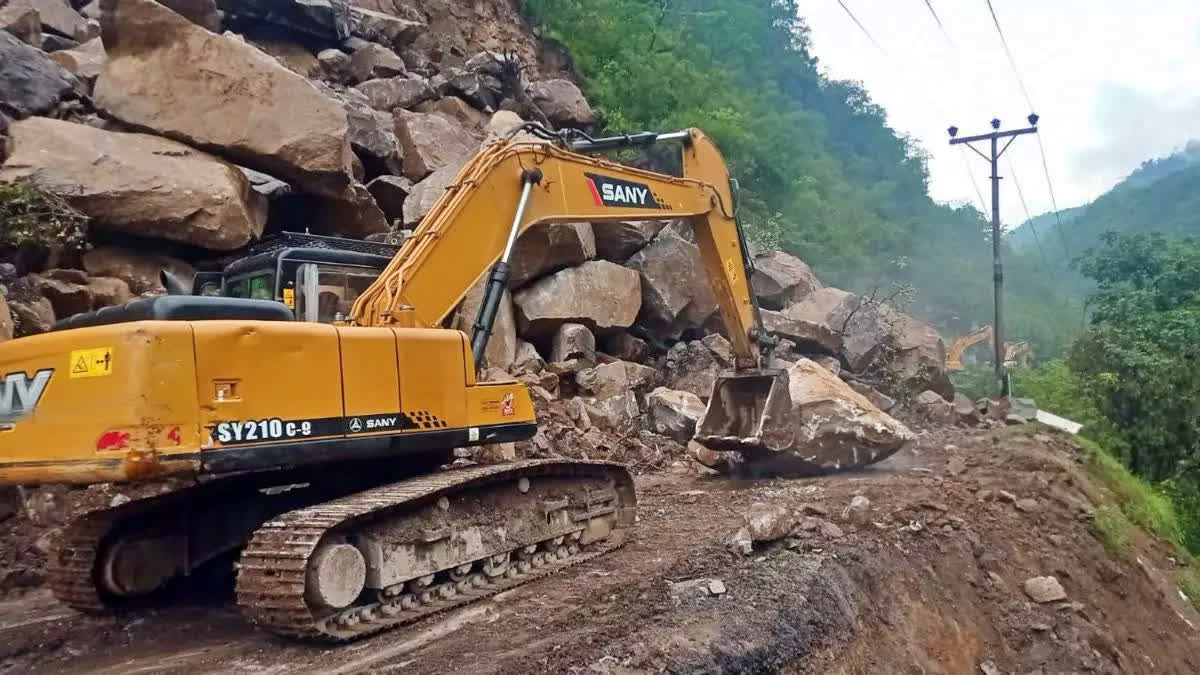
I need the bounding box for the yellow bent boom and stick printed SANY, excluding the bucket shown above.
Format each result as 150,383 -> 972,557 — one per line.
350,129 -> 767,368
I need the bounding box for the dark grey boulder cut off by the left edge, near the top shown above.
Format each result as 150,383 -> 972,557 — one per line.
0,30 -> 79,117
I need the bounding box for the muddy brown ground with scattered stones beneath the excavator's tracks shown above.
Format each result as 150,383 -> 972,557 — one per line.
0,426 -> 1200,673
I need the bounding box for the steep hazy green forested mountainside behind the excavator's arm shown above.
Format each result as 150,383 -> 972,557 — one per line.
523,0 -> 1082,356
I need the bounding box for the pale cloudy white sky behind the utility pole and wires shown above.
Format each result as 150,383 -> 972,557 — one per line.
800,0 -> 1200,226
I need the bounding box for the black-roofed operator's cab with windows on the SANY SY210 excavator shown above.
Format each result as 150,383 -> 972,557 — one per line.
177,232 -> 400,323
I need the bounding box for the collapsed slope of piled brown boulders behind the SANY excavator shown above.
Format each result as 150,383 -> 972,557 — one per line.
0,0 -> 950,473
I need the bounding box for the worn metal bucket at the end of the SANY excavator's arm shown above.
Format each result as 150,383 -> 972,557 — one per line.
695,370 -> 796,453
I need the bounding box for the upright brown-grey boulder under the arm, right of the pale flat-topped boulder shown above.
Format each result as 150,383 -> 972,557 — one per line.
625,221 -> 716,338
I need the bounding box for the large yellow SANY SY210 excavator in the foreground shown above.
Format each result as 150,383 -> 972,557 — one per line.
0,125 -> 792,641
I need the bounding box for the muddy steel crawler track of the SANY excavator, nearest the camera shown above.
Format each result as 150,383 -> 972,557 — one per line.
229,460 -> 636,641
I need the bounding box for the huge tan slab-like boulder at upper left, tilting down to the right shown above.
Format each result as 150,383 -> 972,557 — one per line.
95,0 -> 354,198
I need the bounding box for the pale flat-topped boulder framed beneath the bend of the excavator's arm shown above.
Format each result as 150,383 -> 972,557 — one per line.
512,261 -> 642,339
